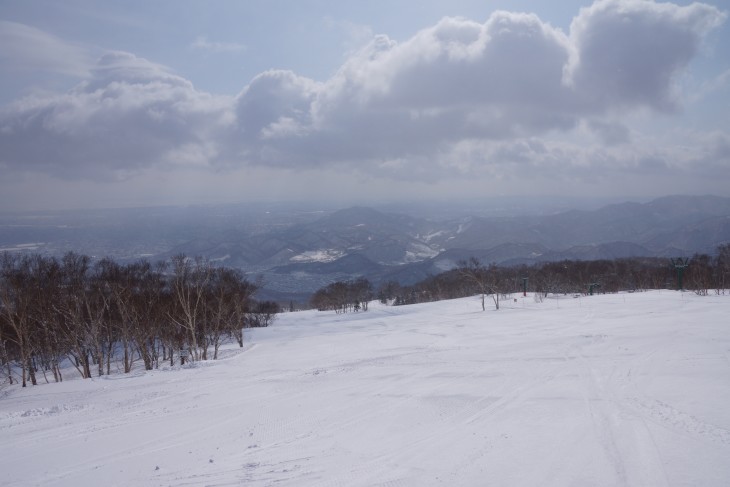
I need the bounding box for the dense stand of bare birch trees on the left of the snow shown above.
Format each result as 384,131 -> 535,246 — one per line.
0,252 -> 278,387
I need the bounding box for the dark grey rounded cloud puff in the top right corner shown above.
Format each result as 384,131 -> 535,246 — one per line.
566,0 -> 726,110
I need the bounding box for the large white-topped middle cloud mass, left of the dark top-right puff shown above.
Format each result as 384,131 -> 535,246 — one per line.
306,12 -> 575,156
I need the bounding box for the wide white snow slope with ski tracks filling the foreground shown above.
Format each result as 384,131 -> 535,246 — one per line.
0,291 -> 730,487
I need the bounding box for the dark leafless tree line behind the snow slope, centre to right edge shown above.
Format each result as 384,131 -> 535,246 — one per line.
310,244 -> 730,312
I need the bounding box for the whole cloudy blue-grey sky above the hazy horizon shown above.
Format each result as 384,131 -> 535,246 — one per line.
0,0 -> 730,210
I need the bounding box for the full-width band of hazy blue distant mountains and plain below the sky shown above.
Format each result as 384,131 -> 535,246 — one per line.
0,196 -> 730,299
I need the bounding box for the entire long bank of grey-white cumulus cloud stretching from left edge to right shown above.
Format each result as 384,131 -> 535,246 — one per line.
0,0 -> 725,188
